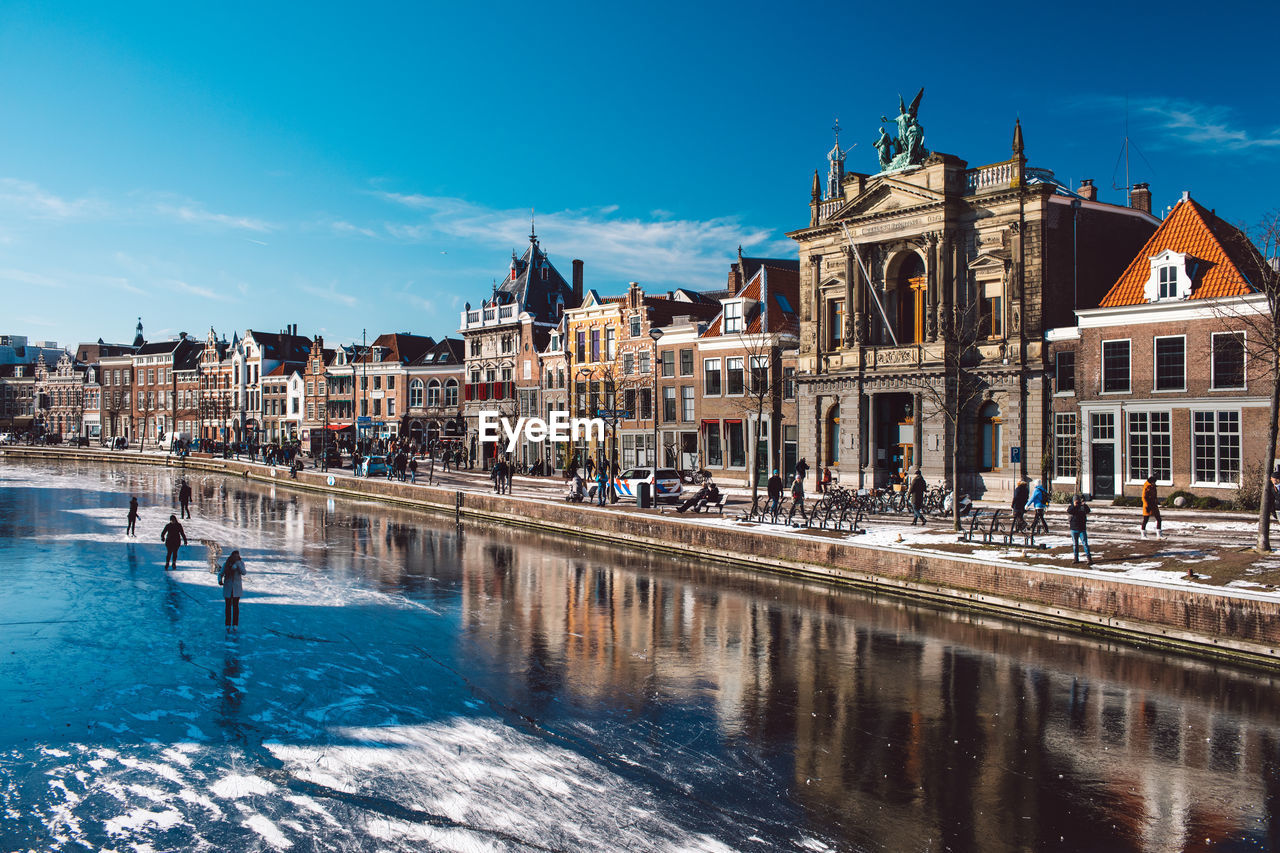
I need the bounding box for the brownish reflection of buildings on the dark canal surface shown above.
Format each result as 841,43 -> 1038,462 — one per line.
462,534 -> 1280,852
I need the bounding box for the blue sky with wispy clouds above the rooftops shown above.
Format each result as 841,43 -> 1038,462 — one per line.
0,1 -> 1280,345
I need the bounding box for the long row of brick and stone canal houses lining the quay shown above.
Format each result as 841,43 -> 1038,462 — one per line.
15,127 -> 1276,497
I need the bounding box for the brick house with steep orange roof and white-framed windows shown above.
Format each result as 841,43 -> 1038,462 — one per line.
1047,193 -> 1276,498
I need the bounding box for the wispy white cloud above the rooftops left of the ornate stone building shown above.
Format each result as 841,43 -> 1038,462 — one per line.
374,192 -> 795,288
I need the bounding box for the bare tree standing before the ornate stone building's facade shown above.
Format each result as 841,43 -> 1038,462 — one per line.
909,302 -> 988,530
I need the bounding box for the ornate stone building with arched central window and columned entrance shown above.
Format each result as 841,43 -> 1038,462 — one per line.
790,116 -> 1158,497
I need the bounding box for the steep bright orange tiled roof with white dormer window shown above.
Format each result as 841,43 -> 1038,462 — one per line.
1100,197 -> 1268,307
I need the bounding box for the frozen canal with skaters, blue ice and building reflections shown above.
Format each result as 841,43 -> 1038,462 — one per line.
0,462 -> 1280,853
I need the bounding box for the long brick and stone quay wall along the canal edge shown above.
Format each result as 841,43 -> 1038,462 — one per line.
3,447 -> 1280,670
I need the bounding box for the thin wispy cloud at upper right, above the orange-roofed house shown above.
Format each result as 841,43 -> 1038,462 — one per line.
1075,95 -> 1280,154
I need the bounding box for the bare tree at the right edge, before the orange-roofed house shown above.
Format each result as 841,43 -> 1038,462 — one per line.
1217,210 -> 1280,551
